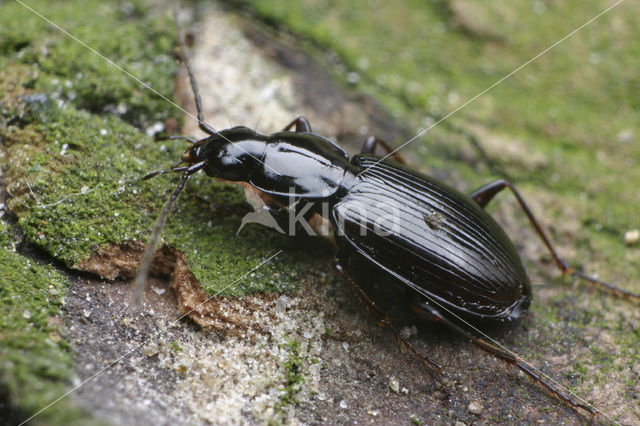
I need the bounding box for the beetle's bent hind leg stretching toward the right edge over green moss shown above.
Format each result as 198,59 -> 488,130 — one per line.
469,179 -> 640,299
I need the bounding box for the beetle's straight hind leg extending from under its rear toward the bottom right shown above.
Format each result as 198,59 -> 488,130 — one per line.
413,302 -> 600,417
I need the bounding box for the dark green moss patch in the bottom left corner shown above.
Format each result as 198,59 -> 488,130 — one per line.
0,236 -> 86,424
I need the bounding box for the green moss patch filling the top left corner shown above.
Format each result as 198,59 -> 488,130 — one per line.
0,0 -> 175,126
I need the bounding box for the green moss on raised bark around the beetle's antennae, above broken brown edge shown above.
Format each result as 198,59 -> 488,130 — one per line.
0,2 -> 323,294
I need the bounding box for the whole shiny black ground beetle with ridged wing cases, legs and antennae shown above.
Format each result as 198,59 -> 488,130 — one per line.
135,9 -> 640,416
